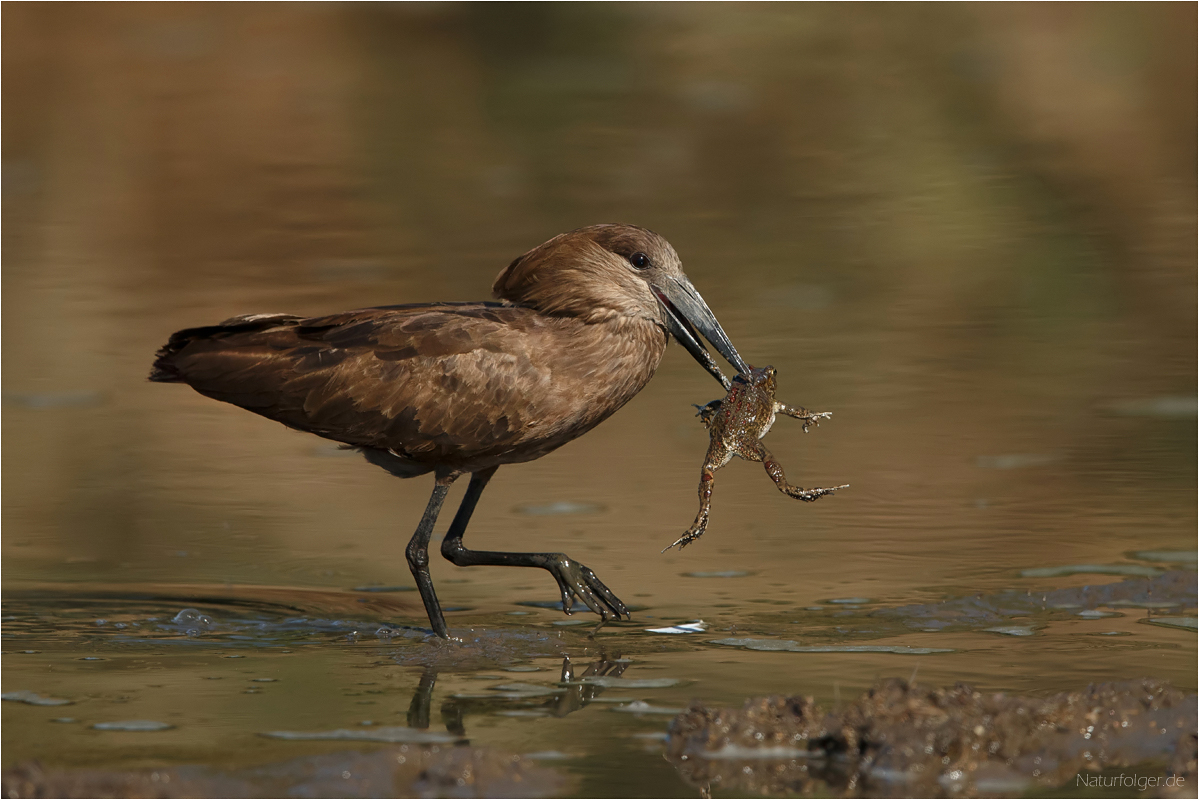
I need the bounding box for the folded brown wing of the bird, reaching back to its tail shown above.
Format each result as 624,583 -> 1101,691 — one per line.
151,303 -> 553,463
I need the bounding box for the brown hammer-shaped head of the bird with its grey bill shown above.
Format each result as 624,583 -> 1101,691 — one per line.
492,224 -> 749,389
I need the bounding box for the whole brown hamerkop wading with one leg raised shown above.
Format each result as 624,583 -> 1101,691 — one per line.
150,224 -> 748,638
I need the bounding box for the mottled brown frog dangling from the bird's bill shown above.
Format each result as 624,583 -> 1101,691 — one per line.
662,366 -> 849,553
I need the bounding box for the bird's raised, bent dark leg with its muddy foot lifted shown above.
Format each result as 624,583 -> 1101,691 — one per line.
441,467 -> 629,620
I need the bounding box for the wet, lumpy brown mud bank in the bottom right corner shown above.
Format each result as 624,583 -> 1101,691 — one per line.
667,679 -> 1197,796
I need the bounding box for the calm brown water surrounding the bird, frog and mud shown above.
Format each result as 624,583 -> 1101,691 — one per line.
0,5 -> 1197,796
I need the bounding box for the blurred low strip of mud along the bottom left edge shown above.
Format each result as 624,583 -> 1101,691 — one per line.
2,745 -> 568,798
